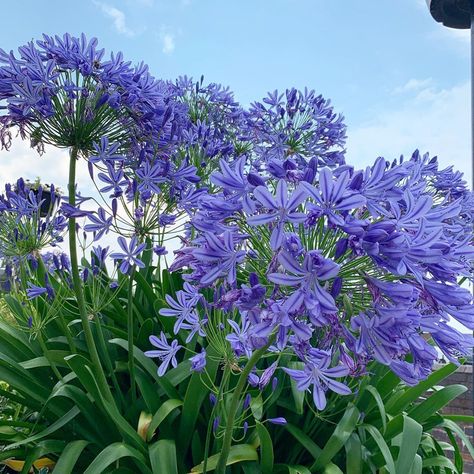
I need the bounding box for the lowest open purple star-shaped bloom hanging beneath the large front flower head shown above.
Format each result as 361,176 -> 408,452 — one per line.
283,349 -> 351,410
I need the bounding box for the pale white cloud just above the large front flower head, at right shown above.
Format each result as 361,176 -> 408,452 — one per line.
347,83 -> 471,183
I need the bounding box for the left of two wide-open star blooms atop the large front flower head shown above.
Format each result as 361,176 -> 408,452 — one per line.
247,179 -> 307,250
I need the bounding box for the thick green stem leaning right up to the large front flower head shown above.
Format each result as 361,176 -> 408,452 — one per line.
216,334 -> 276,474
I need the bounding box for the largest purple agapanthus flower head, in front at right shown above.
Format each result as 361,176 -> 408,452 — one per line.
157,143 -> 474,409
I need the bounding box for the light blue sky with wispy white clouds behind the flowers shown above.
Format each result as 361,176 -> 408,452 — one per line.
0,0 -> 470,189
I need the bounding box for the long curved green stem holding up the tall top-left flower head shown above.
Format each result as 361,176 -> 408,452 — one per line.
68,147 -> 114,402
